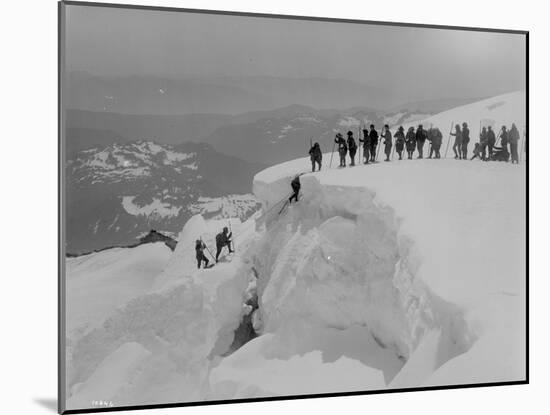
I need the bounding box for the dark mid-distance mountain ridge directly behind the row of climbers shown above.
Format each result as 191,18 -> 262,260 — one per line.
66,105 -> 433,164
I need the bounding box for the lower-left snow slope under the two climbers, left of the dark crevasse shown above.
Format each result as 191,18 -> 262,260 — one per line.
67,215 -> 255,409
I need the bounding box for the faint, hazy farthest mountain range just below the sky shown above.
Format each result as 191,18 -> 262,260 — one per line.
64,71 -> 392,115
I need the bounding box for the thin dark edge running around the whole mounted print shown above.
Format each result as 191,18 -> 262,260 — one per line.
57,0 -> 530,414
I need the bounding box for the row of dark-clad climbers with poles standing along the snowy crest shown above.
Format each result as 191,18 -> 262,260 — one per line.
309,122 -> 520,172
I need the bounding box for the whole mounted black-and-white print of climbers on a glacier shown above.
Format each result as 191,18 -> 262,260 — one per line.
59,1 -> 528,413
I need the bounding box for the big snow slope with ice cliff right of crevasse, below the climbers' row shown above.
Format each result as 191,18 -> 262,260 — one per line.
245,159 -> 526,396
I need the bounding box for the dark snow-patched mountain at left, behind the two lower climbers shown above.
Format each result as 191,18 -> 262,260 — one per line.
65,141 -> 265,255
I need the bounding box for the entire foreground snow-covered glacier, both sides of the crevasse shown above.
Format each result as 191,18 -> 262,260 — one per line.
62,94 -> 527,409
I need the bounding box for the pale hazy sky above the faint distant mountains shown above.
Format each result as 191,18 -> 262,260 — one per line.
62,6 -> 525,99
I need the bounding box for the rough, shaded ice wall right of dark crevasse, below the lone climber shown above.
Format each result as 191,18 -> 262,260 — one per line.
211,176 -> 475,397
